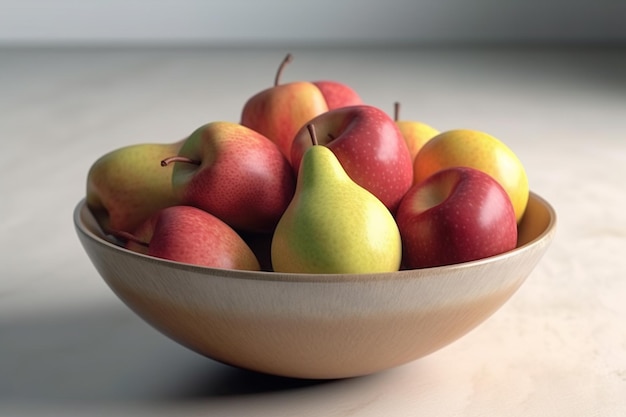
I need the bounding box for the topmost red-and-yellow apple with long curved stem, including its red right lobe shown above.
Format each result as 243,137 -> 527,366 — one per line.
241,54 -> 361,159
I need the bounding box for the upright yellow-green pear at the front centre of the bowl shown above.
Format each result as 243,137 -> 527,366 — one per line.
271,127 -> 402,274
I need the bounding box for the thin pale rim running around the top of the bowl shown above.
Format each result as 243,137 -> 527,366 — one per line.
73,191 -> 557,283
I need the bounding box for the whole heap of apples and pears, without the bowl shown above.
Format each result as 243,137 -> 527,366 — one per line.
86,54 -> 529,273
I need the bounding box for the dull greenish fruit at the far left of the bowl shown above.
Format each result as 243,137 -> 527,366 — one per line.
86,141 -> 183,234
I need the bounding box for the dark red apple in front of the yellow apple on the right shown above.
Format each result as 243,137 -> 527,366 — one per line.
396,167 -> 517,269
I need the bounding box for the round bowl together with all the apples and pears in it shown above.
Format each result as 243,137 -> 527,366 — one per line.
74,51 -> 556,378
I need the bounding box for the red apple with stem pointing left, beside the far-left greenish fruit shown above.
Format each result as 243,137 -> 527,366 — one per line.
167,122 -> 296,232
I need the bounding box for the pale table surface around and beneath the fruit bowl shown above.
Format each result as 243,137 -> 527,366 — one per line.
0,47 -> 626,417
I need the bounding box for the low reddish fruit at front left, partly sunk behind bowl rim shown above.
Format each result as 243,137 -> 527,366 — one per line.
126,206 -> 260,271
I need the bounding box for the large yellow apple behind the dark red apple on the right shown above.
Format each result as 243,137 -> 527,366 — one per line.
413,129 -> 529,222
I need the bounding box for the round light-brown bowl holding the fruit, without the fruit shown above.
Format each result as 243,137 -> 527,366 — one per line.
74,193 -> 556,379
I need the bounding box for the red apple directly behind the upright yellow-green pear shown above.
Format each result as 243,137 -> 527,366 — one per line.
291,105 -> 413,212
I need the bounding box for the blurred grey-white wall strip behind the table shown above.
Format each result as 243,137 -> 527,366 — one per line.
0,0 -> 626,44
